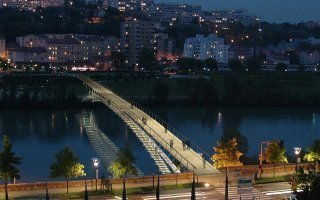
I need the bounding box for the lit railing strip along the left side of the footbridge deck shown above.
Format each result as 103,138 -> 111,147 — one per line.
94,93 -> 197,171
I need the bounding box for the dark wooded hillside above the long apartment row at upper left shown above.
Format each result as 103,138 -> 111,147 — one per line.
0,5 -> 123,42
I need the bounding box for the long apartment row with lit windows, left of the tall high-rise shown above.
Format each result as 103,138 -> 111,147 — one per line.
7,34 -> 119,69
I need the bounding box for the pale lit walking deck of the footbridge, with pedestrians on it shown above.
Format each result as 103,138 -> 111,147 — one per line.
79,76 -> 219,175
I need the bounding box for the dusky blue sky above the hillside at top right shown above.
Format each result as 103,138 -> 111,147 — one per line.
155,0 -> 320,23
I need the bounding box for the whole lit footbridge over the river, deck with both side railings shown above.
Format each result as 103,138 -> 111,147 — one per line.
78,76 -> 219,175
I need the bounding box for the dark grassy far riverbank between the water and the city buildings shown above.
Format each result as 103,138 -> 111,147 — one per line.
0,72 -> 320,108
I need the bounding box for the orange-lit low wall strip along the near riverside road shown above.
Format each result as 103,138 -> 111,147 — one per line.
0,165 -> 293,199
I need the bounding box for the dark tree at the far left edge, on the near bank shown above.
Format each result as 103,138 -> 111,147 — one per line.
0,135 -> 22,199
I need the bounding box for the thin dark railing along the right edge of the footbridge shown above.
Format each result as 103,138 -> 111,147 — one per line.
94,80 -> 212,164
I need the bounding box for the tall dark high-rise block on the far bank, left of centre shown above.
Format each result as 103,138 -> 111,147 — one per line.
120,20 -> 157,65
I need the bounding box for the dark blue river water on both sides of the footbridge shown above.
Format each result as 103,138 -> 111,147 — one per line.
0,107 -> 320,182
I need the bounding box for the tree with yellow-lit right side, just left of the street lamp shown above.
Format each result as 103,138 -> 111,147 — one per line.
50,147 -> 86,193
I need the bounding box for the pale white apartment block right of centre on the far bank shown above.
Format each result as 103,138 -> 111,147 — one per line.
183,34 -> 229,63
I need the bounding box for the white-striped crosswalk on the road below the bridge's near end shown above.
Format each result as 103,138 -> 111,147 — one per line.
216,187 -> 273,200
